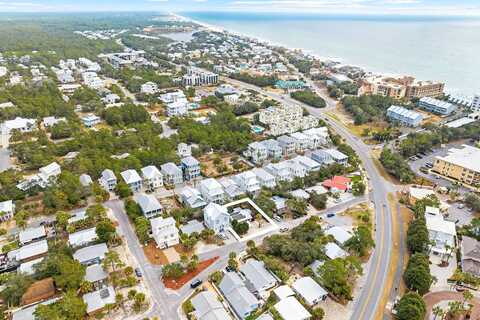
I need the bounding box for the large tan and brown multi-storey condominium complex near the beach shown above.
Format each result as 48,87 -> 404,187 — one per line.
359,76 -> 445,99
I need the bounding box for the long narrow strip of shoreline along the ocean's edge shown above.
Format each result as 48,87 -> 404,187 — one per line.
170,13 -> 473,99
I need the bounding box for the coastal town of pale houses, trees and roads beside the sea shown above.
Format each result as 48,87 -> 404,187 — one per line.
0,11 -> 480,320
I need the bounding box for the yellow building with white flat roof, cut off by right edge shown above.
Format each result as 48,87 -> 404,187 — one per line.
433,145 -> 480,186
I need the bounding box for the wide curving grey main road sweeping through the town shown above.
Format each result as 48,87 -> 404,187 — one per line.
222,78 -> 399,320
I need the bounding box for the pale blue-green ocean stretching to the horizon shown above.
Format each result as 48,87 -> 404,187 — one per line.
180,12 -> 480,97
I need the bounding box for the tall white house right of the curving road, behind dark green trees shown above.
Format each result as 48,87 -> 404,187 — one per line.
425,215 -> 457,254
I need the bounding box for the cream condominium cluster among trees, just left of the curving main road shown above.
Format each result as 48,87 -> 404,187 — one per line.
259,105 -> 318,136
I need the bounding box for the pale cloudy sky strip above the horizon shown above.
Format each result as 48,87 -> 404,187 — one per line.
0,0 -> 480,16
